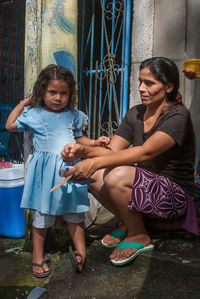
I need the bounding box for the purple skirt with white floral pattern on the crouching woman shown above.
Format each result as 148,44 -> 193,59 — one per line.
128,167 -> 198,234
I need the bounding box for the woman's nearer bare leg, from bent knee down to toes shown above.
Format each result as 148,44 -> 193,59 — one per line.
104,166 -> 150,260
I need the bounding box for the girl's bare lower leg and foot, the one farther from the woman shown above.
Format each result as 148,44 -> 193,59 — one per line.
32,226 -> 49,274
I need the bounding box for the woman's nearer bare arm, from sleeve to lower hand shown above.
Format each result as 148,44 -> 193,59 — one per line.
61,131 -> 175,180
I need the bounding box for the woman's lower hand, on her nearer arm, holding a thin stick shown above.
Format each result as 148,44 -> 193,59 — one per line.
64,159 -> 97,181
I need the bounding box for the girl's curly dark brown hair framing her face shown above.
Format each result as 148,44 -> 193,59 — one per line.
31,64 -> 76,109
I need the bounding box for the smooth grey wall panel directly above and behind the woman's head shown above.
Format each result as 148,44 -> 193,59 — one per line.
153,0 -> 189,107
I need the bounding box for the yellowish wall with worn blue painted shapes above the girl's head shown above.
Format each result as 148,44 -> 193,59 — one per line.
25,0 -> 77,94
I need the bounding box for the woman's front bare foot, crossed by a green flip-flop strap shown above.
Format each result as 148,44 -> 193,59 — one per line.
110,234 -> 151,261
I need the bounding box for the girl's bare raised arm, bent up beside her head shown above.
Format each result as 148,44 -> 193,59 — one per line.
6,97 -> 31,132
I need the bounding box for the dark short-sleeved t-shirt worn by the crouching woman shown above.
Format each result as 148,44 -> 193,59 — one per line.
115,105 -> 195,195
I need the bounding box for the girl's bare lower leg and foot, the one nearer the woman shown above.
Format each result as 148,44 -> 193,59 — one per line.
67,222 -> 86,272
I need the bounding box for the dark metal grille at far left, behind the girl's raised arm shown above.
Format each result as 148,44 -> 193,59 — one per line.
0,0 -> 25,162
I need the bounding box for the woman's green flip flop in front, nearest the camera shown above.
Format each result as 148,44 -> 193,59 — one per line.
110,242 -> 154,266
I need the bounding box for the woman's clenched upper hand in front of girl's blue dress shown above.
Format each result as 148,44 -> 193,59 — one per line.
61,143 -> 84,162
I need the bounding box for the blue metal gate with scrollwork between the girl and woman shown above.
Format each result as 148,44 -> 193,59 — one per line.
78,0 -> 132,138
